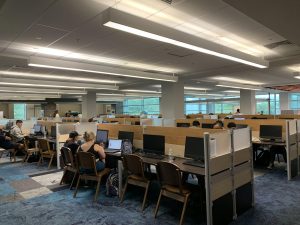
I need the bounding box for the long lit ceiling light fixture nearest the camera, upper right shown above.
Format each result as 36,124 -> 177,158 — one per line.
103,8 -> 268,68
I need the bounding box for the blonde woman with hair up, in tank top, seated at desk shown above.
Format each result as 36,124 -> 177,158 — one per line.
78,132 -> 106,171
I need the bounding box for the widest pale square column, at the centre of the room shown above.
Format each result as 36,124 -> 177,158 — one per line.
160,81 -> 184,119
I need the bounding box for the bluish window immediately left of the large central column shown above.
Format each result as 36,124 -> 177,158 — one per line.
123,98 -> 160,115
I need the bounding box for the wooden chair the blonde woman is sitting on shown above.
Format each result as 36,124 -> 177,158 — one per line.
73,152 -> 110,201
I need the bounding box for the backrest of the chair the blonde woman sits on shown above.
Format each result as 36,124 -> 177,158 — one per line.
76,152 -> 97,174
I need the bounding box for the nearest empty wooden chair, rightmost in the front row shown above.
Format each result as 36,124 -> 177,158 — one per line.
154,161 -> 191,225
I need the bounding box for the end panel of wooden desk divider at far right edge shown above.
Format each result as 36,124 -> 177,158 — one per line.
286,120 -> 299,180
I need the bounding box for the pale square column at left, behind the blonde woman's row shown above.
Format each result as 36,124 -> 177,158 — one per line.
81,91 -> 97,119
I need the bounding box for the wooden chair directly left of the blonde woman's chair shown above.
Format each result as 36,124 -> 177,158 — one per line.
60,147 -> 78,189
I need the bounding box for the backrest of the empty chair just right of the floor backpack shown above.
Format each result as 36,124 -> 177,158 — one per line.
124,154 -> 145,177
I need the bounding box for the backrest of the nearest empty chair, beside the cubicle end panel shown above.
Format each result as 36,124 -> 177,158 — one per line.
156,161 -> 182,193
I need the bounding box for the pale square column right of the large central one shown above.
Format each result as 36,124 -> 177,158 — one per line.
240,89 -> 256,114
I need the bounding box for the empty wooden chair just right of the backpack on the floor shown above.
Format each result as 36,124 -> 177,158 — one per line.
121,154 -> 150,211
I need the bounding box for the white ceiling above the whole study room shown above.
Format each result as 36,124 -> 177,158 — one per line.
0,0 -> 300,100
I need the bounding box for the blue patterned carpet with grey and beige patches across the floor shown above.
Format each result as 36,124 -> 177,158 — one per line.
0,163 -> 300,225
